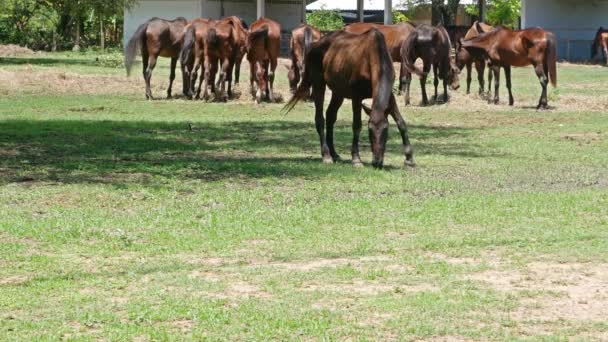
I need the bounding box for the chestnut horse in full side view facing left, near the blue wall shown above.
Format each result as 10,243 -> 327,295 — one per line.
461,27 -> 557,109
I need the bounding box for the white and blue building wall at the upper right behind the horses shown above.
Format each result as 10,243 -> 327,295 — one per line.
522,0 -> 608,61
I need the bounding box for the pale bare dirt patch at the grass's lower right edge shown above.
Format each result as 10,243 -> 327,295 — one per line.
470,262 -> 608,322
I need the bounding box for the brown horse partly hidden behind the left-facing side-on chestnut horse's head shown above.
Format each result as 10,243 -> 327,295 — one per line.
452,21 -> 494,95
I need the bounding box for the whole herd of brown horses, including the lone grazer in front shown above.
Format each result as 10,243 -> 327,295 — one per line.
125,17 -> 568,168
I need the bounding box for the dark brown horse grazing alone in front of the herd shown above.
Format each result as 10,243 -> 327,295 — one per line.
285,29 -> 414,168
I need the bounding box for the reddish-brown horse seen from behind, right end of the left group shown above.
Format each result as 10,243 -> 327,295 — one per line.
247,18 -> 281,103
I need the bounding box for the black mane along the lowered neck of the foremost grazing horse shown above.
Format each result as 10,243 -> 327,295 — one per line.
370,29 -> 395,111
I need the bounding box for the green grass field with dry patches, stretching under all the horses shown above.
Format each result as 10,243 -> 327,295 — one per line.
0,54 -> 608,341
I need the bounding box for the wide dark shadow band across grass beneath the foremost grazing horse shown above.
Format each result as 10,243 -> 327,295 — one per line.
0,120 -> 504,185
